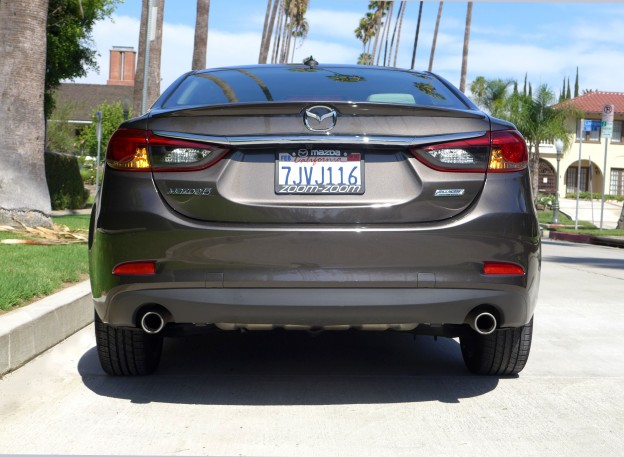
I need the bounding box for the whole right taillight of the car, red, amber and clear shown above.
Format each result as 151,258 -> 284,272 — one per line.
410,130 -> 529,173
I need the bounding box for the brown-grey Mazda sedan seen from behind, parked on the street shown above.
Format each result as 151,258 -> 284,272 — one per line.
89,61 -> 541,375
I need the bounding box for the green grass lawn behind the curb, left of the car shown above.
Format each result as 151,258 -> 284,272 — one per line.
0,215 -> 89,311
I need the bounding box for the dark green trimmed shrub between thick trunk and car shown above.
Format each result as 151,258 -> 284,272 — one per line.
45,152 -> 89,209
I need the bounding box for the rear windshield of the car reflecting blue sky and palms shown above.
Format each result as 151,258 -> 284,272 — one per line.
162,66 -> 468,109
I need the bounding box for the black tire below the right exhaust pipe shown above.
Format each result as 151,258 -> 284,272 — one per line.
459,318 -> 533,376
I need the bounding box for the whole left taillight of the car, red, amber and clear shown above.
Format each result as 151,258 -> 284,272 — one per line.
106,128 -> 227,171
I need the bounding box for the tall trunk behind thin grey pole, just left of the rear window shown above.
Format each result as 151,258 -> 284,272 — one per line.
132,0 -> 165,115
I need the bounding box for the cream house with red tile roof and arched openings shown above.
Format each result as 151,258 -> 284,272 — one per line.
539,91 -> 624,196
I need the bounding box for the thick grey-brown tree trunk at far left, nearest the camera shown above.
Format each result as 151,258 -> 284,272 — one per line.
0,0 -> 51,226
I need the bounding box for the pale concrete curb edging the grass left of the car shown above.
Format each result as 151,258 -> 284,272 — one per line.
0,280 -> 93,376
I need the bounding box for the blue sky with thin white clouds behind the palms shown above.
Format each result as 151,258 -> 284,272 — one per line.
76,0 -> 624,95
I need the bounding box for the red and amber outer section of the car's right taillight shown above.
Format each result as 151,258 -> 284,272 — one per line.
488,130 -> 529,173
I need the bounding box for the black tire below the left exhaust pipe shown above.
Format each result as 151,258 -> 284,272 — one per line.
95,313 -> 163,376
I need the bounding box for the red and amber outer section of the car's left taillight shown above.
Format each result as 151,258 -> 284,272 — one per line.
106,128 -> 150,171
